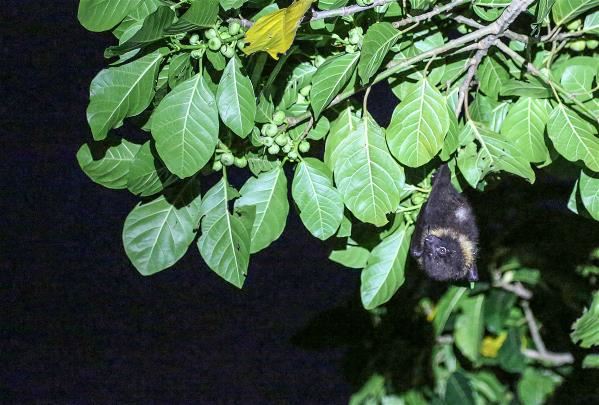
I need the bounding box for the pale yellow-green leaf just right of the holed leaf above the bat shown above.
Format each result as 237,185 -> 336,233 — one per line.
501,97 -> 551,162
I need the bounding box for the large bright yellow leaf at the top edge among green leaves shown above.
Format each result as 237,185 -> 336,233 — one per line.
243,0 -> 312,59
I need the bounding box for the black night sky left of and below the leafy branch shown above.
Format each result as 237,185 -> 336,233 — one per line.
0,0 -> 400,403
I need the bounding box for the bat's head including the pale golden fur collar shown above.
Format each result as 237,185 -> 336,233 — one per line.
421,232 -> 478,281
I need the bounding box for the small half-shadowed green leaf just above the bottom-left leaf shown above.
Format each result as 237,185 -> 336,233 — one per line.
127,141 -> 177,197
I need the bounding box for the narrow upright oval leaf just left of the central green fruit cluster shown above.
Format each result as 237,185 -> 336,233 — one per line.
216,58 -> 256,138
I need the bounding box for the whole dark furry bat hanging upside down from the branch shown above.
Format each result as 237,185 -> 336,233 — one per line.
410,164 -> 478,281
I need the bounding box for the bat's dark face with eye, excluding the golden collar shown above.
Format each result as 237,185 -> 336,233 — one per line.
421,234 -> 468,281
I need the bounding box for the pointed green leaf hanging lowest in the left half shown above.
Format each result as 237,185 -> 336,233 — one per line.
198,177 -> 250,288
